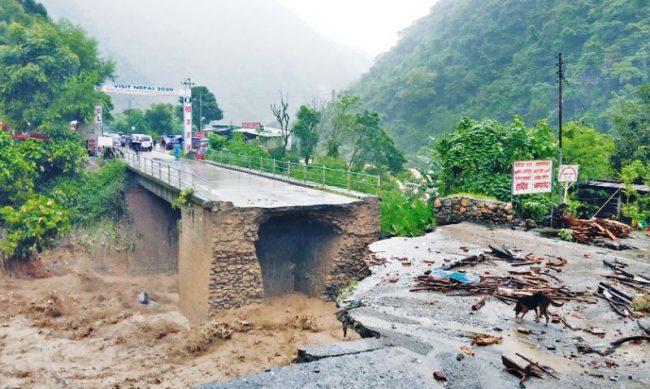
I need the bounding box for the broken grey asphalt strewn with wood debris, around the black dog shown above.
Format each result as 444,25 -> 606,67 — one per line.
203,223 -> 650,389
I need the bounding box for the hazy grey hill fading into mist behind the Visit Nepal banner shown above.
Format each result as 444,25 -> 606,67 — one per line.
41,0 -> 371,122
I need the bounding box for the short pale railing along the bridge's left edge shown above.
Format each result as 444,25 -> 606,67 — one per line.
123,150 -> 212,200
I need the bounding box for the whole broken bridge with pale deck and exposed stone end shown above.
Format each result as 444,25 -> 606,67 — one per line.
124,152 -> 379,324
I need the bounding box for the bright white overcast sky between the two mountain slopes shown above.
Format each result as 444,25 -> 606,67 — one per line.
278,0 -> 436,56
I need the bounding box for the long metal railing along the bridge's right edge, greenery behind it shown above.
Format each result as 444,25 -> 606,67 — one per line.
205,150 -> 381,194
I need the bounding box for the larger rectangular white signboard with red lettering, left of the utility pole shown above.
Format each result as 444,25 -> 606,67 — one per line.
512,160 -> 553,195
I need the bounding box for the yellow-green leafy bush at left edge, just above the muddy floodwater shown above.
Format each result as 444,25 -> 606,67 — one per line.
0,195 -> 71,259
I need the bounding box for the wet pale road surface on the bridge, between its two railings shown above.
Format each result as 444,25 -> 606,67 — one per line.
133,151 -> 363,208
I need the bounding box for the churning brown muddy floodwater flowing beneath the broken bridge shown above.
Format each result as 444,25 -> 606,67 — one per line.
0,236 -> 350,389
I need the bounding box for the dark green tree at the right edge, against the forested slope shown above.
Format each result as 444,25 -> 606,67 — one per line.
612,84 -> 650,171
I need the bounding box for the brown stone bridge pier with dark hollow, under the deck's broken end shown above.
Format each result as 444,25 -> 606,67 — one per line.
178,197 -> 379,324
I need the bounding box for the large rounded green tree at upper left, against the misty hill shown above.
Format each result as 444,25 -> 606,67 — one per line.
0,17 -> 113,130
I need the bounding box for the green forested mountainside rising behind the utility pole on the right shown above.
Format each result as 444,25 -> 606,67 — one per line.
354,0 -> 650,153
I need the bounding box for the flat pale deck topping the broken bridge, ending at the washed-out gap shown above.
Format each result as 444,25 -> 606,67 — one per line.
125,151 -> 367,208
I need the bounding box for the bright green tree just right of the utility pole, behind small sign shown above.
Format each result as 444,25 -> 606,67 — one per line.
562,122 -> 616,181
